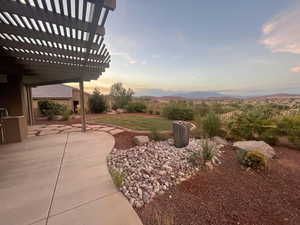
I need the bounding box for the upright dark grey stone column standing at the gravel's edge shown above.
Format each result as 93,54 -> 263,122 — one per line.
172,121 -> 190,148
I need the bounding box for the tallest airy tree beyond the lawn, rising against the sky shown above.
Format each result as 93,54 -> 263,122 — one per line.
110,83 -> 134,109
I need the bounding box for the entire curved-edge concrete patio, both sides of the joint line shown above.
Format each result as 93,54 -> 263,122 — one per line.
0,132 -> 142,225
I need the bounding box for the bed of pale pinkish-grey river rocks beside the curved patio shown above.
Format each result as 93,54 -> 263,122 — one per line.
108,138 -> 223,208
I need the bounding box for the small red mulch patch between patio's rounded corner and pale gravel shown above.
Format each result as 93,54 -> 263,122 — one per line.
114,131 -> 149,150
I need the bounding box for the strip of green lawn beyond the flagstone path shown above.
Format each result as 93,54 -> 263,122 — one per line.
90,114 -> 172,131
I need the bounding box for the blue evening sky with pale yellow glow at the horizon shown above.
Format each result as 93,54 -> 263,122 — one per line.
72,0 -> 300,96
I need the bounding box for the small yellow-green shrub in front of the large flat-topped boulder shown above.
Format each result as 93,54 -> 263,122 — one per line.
242,151 -> 268,169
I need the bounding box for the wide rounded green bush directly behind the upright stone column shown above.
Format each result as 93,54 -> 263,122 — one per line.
162,102 -> 194,120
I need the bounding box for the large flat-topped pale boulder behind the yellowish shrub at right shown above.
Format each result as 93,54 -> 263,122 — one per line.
233,141 -> 276,159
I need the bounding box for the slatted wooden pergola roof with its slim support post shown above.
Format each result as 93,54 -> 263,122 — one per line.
0,0 -> 116,131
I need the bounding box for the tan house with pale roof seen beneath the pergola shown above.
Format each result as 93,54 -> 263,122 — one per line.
32,84 -> 90,116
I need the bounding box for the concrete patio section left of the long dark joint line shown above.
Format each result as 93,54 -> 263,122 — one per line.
0,135 -> 67,225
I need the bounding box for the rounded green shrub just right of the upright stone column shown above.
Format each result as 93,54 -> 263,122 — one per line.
197,112 -> 221,137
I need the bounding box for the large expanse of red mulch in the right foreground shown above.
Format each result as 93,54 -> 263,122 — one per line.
136,147 -> 300,225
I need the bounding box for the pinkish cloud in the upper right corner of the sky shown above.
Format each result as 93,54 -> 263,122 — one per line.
260,3 -> 300,54
